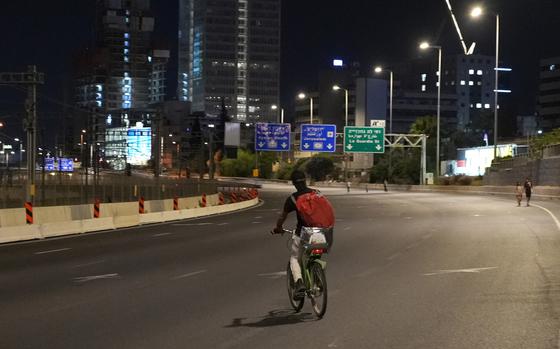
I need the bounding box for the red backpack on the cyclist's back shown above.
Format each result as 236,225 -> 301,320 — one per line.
292,191 -> 334,228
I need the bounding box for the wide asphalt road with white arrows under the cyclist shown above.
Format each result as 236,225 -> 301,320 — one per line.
0,185 -> 560,349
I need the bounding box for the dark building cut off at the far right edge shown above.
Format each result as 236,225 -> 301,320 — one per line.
538,57 -> 560,131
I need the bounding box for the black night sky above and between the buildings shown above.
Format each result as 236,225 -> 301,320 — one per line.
0,0 -> 560,141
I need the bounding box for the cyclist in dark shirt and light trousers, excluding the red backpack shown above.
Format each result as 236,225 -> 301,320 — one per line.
273,170 -> 334,298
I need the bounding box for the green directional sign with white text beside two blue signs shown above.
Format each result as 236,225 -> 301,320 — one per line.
344,126 -> 385,153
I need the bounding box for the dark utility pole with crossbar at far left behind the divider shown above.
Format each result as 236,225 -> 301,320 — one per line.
0,65 -> 45,202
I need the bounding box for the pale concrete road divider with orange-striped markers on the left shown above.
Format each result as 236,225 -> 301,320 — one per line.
0,194 -> 259,243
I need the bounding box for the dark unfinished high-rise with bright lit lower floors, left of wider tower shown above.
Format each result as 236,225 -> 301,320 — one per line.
75,0 -> 170,167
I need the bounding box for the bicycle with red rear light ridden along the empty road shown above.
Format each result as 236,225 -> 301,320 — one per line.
274,228 -> 328,319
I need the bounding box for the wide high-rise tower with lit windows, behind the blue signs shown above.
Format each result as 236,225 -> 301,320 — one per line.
177,0 -> 281,122
